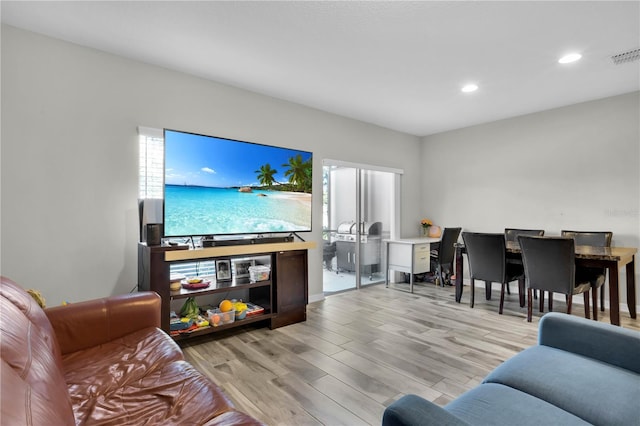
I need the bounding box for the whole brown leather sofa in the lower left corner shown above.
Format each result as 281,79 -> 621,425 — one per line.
0,277 -> 261,425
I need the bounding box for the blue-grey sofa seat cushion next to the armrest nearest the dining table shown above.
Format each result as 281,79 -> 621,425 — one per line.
483,345 -> 640,425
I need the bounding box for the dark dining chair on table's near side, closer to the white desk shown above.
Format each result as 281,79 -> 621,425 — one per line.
462,232 -> 524,314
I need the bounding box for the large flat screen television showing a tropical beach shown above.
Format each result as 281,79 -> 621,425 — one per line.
163,129 -> 312,238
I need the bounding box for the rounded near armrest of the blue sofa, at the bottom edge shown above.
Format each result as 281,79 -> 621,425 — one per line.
382,395 -> 468,426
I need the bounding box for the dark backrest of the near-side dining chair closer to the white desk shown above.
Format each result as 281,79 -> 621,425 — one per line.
462,232 -> 506,283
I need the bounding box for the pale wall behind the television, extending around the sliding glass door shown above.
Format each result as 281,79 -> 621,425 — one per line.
0,25 -> 421,306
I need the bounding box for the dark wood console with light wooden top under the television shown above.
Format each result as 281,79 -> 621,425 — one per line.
138,242 -> 315,340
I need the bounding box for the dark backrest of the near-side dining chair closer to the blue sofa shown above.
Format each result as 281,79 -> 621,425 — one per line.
518,235 -> 576,294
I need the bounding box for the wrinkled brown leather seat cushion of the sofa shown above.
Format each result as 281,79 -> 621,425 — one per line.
62,327 -> 241,425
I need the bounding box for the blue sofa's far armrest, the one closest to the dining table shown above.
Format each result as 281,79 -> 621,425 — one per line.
538,312 -> 640,374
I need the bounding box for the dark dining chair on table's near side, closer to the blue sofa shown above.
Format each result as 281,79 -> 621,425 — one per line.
518,235 -> 597,322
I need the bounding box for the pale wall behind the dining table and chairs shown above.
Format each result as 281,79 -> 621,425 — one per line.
422,92 -> 640,309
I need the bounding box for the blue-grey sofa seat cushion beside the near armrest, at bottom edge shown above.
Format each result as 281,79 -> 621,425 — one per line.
444,383 -> 589,426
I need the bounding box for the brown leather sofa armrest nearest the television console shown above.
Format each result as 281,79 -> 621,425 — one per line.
45,291 -> 161,355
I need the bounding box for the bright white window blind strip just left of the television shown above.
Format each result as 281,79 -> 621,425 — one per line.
138,127 -> 164,200
